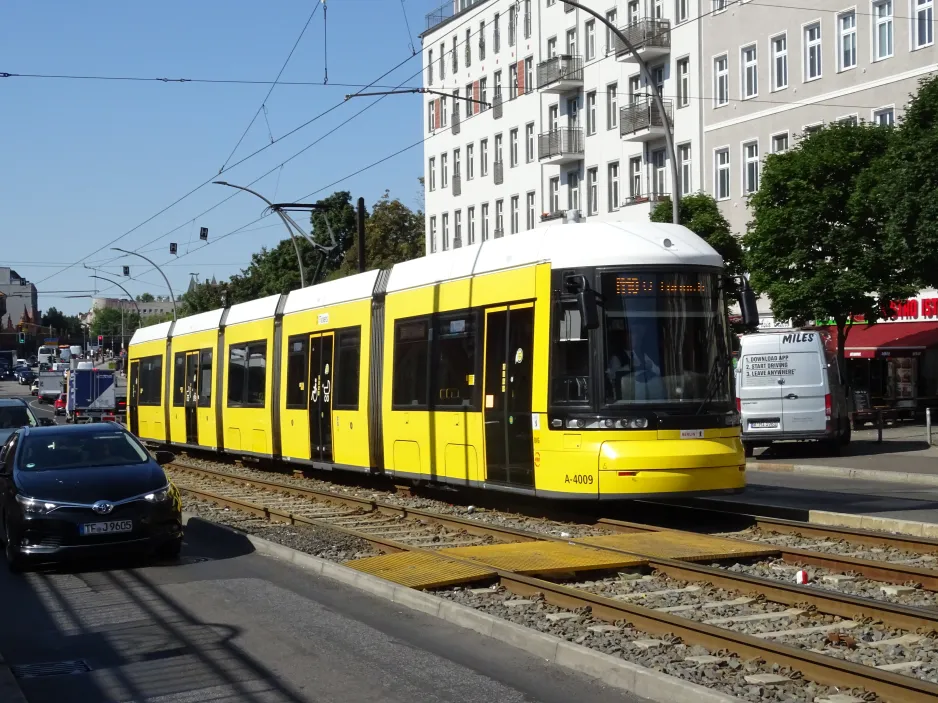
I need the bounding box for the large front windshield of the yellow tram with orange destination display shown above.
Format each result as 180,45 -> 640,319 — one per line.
601,271 -> 731,406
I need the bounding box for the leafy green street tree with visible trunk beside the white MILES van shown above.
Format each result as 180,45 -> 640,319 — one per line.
743,124 -> 916,377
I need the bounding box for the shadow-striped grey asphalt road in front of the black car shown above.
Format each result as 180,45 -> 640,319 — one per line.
0,520 -> 640,703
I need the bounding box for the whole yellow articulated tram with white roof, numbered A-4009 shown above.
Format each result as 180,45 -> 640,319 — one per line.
128,222 -> 745,499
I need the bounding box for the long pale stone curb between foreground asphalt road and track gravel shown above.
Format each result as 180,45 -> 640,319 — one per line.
183,513 -> 740,703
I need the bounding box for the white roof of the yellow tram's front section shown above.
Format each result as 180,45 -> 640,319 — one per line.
388,222 -> 723,293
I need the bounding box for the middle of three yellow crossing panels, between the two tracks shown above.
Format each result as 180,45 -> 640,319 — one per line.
439,542 -> 646,574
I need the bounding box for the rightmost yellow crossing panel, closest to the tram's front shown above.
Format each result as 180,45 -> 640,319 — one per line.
578,530 -> 778,561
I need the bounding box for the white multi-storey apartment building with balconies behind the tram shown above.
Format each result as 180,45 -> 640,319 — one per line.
421,0 -> 709,254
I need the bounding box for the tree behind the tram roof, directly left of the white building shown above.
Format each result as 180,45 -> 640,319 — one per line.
331,191 -> 424,278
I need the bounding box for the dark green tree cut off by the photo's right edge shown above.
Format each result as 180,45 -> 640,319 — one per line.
864,77 -> 938,286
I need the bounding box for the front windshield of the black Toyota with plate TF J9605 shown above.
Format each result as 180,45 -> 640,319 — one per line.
18,430 -> 149,471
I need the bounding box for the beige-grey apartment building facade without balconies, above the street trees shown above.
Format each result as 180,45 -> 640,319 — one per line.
700,0 -> 938,234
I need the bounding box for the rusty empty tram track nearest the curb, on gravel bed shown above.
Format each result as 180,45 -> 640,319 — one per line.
169,463 -> 938,701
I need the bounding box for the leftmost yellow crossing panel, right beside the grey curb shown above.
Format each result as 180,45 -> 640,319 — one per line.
345,552 -> 495,588
